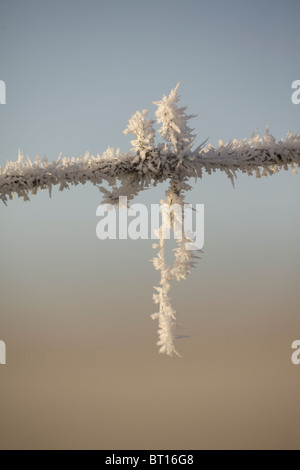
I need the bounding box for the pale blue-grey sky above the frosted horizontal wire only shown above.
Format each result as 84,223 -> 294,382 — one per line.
0,0 -> 300,165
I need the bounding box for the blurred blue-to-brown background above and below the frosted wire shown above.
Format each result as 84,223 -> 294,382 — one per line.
0,0 -> 300,449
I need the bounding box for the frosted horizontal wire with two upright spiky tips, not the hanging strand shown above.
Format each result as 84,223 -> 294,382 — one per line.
0,84 -> 300,203
